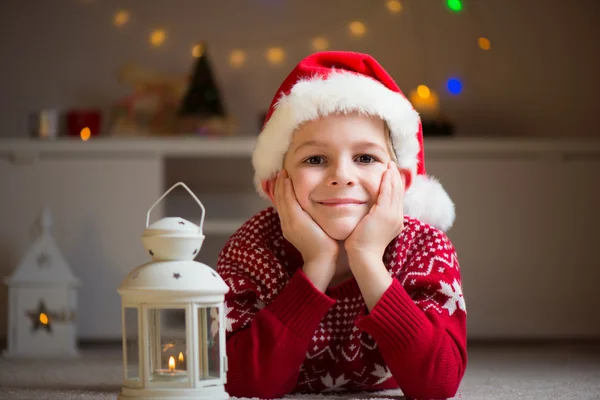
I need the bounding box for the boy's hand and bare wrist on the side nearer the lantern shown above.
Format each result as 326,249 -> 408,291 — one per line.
274,170 -> 339,291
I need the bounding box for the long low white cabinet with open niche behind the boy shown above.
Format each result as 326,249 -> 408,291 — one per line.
0,138 -> 600,340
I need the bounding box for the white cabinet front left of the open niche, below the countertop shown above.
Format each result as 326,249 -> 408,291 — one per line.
0,155 -> 162,338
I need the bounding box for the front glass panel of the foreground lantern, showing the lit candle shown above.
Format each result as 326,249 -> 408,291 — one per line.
148,308 -> 189,382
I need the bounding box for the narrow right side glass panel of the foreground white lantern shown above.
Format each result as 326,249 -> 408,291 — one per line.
198,307 -> 221,380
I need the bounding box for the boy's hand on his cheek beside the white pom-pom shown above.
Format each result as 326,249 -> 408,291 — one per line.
344,162 -> 404,260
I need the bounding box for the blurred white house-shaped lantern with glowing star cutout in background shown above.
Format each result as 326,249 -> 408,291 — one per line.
3,207 -> 81,358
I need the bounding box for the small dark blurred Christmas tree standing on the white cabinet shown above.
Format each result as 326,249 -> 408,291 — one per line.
179,42 -> 228,135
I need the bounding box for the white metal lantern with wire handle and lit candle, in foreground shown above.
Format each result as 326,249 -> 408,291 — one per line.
118,182 -> 229,400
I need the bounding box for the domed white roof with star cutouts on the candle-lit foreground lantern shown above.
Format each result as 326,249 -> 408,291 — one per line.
118,260 -> 229,299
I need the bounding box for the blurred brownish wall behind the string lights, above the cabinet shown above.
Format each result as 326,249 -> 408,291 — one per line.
0,0 -> 600,137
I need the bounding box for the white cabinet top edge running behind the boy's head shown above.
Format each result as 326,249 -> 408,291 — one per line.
0,135 -> 600,158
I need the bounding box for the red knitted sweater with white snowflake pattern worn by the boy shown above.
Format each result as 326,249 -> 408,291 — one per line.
217,208 -> 467,399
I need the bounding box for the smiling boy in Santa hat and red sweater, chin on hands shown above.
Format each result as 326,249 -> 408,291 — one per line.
217,52 -> 467,399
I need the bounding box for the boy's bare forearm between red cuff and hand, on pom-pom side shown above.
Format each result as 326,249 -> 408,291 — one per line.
348,253 -> 393,312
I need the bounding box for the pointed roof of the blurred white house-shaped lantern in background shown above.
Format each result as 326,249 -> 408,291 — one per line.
5,207 -> 81,287
